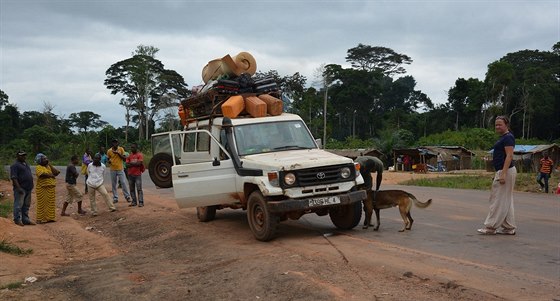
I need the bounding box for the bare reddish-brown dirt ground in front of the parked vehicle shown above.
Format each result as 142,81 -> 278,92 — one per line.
0,171 -> 556,300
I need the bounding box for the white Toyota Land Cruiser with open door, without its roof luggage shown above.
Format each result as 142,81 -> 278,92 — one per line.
149,113 -> 366,241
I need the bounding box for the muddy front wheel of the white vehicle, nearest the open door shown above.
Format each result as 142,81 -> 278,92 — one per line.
247,191 -> 280,241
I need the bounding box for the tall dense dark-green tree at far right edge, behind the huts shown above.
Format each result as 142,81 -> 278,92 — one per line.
485,43 -> 560,141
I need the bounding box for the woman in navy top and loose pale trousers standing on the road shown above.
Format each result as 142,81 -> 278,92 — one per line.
477,116 -> 517,235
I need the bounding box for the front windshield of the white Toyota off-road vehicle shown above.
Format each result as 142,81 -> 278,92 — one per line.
235,120 -> 317,156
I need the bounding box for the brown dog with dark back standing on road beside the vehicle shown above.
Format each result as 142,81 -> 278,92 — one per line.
363,190 -> 432,232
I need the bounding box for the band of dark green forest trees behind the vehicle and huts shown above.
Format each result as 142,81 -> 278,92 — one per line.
0,42 -> 560,165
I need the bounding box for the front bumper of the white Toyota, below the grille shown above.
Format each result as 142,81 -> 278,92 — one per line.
267,190 -> 367,213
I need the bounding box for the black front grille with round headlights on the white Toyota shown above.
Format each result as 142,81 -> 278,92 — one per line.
280,164 -> 356,188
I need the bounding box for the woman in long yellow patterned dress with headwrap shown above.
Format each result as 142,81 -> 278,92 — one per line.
35,153 -> 60,223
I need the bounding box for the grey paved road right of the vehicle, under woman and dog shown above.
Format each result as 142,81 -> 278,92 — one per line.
299,185 -> 560,300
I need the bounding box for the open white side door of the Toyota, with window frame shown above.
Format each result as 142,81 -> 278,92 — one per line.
171,130 -> 237,208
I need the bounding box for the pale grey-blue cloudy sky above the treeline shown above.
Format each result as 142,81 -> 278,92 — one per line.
0,0 -> 560,127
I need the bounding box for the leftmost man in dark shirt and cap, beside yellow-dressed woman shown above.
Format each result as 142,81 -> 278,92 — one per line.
10,151 -> 35,226
